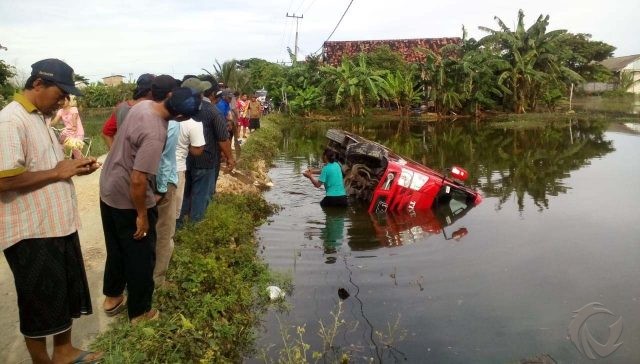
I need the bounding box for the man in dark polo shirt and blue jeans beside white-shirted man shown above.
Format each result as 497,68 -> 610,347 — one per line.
179,81 -> 236,224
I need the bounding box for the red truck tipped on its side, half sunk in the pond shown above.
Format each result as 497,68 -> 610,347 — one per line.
326,129 -> 482,213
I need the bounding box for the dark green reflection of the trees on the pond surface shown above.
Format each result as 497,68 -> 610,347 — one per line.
283,118 -> 614,211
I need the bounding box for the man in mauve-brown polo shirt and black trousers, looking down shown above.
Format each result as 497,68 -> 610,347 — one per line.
100,75 -> 201,324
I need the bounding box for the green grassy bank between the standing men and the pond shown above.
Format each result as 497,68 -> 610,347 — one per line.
93,114 -> 282,363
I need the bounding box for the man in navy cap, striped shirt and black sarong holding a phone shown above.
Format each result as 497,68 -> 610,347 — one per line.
0,59 -> 102,363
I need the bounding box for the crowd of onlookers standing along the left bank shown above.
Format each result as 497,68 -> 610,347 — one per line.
0,59 -> 262,363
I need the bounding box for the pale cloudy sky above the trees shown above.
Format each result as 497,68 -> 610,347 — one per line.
0,0 -> 640,81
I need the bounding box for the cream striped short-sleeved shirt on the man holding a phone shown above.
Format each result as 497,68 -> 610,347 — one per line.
0,94 -> 80,250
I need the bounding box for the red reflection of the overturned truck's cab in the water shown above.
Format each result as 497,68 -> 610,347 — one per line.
370,192 -> 474,247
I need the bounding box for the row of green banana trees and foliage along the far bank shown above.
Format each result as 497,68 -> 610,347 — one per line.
0,10 -> 624,114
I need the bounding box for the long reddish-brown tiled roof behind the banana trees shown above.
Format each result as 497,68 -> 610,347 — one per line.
322,37 -> 462,66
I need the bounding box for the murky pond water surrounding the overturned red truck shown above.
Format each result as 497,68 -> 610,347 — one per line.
247,119 -> 640,363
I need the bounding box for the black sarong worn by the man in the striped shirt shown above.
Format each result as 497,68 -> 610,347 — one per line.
4,232 -> 92,338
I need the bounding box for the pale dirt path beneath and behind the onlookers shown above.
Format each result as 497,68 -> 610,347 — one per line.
0,149 -> 266,364
